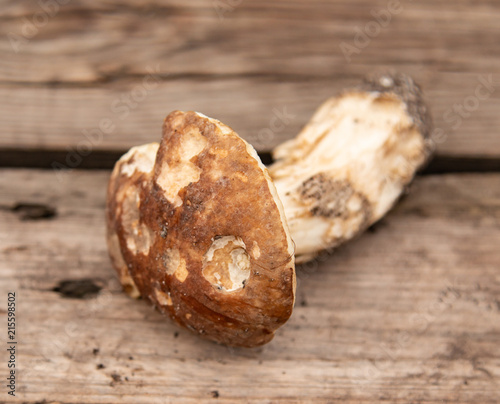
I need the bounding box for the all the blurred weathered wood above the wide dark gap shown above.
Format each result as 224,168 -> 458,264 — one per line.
0,0 -> 500,156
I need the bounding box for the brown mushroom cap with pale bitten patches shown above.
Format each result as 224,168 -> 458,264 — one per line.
106,111 -> 296,347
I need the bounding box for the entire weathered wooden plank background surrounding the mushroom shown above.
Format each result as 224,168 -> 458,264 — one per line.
0,0 -> 500,404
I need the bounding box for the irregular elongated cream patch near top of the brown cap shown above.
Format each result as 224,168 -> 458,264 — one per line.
156,126 -> 207,207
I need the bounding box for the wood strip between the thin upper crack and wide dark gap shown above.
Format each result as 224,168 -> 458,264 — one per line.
0,74 -> 500,156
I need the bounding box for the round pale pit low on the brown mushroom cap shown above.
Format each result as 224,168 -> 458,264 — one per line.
203,236 -> 250,292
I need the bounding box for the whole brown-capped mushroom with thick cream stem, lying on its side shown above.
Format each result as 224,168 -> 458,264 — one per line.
107,75 -> 431,347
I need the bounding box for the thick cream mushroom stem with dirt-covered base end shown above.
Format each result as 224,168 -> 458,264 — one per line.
269,75 -> 431,263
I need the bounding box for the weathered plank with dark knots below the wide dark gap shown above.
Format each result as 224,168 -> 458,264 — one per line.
0,170 -> 500,404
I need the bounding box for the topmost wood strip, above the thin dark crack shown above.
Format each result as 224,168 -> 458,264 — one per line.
0,0 -> 500,83
